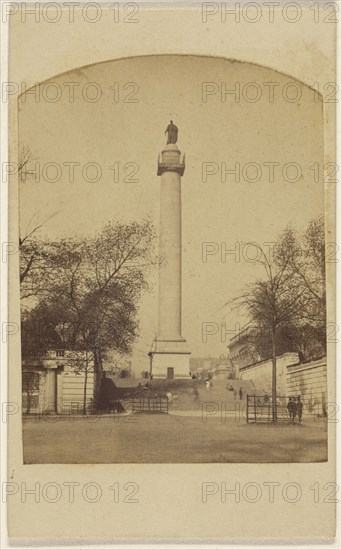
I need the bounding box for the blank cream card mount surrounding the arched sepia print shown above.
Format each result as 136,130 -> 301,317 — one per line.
8,3 -> 336,543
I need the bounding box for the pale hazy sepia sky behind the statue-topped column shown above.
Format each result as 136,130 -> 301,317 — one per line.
19,56 -> 323,371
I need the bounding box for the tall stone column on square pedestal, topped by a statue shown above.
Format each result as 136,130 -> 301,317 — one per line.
152,121 -> 190,378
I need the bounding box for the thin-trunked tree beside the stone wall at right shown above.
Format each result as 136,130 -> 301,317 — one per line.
228,218 -> 326,422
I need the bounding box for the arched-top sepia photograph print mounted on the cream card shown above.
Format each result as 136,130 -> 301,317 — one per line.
18,55 -> 328,464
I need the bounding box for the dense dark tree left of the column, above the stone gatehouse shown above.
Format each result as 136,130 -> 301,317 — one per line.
22,221 -> 155,414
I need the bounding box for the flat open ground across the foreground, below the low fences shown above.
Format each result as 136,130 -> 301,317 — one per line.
23,414 -> 327,464
